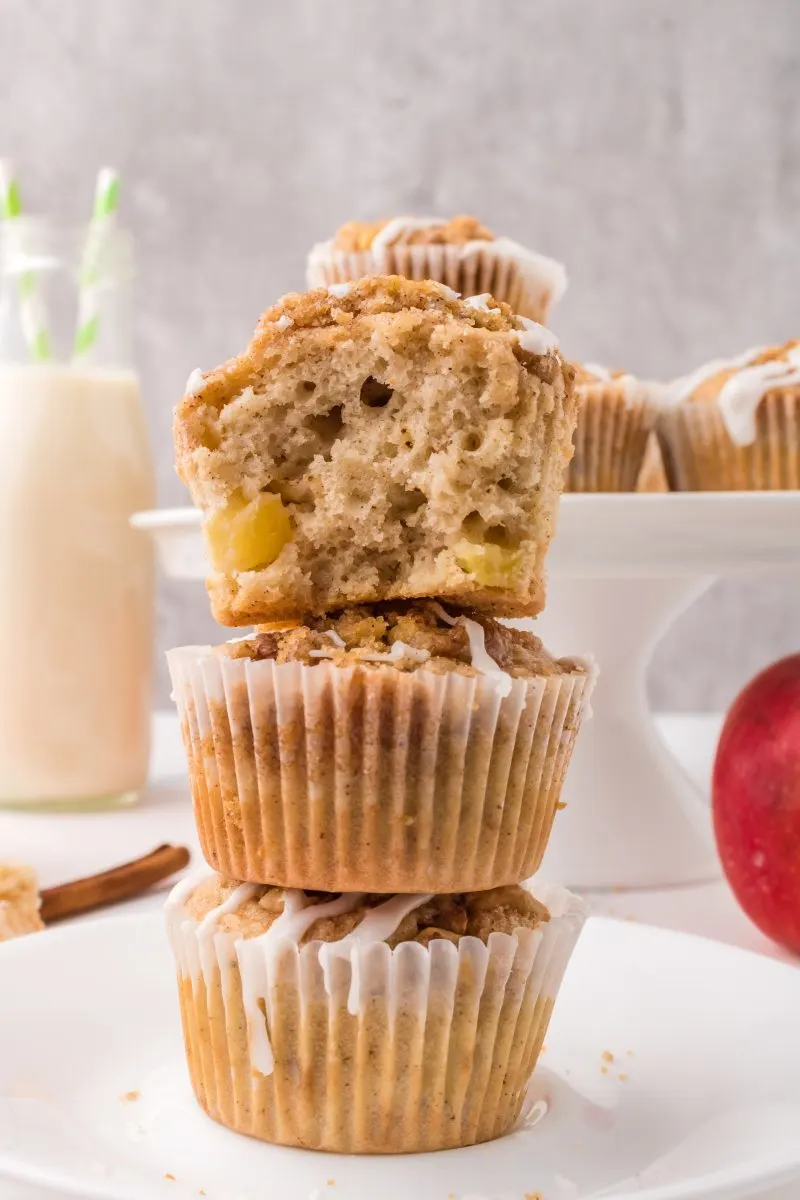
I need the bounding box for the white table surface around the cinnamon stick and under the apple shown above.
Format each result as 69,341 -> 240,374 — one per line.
0,713 -> 800,1200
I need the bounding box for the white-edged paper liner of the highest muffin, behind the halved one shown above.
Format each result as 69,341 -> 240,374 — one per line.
306,238 -> 567,324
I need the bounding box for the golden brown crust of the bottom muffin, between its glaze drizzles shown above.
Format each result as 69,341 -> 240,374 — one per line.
185,875 -> 549,949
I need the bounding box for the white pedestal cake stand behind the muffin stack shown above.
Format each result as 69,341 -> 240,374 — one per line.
133,492 -> 800,889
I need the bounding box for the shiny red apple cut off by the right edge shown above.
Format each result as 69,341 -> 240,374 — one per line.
711,654 -> 800,954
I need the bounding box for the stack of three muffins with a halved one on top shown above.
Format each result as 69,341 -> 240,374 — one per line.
168,270 -> 593,1153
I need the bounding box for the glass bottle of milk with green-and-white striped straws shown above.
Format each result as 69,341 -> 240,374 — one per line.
0,218 -> 154,808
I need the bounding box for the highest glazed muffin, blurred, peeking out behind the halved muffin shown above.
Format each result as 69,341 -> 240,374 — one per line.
306,216 -> 567,323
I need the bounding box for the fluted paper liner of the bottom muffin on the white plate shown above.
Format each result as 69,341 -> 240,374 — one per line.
168,886 -> 587,1153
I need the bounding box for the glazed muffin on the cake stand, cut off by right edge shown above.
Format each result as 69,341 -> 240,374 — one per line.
657,340 -> 800,492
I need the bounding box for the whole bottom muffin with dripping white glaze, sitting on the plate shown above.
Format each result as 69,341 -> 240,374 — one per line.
167,876 -> 585,1154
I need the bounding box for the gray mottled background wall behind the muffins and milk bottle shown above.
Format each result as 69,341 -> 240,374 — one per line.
0,0 -> 800,708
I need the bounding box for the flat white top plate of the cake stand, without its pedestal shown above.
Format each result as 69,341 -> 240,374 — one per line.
132,491 -> 800,580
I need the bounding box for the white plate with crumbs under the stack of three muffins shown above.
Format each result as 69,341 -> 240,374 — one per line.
0,914 -> 800,1200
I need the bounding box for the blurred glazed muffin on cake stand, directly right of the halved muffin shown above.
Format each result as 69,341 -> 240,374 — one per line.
566,366 -> 657,492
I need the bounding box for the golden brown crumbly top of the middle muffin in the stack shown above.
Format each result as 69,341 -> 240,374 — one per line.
219,600 -> 582,678
